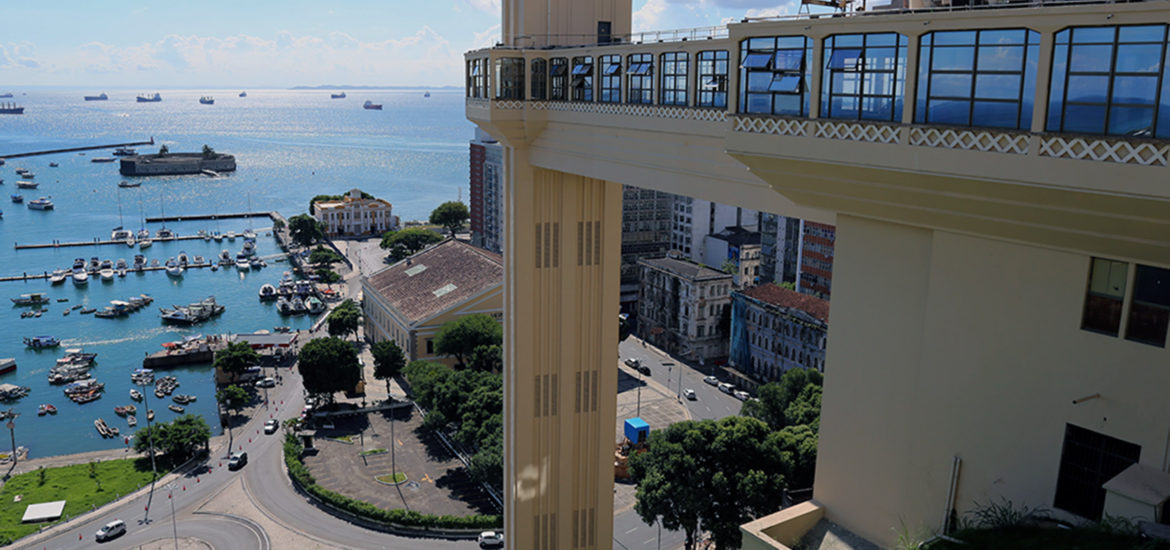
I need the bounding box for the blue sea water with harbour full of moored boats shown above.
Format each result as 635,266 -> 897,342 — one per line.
0,90 -> 473,456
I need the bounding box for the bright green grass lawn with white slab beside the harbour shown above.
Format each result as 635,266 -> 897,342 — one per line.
0,459 -> 160,544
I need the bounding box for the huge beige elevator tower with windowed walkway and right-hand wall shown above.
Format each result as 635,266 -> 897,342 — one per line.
466,0 -> 1170,550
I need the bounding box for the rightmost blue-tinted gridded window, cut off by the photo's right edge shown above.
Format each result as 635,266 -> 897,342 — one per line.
1046,25 -> 1170,137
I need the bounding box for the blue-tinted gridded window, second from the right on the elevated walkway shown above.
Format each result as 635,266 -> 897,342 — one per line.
914,29 -> 1040,129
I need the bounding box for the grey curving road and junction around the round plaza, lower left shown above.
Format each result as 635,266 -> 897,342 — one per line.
16,370 -> 476,550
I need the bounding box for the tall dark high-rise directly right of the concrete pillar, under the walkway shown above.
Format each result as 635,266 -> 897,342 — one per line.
621,185 -> 674,311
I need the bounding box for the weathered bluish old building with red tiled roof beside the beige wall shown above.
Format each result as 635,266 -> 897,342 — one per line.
728,283 -> 828,389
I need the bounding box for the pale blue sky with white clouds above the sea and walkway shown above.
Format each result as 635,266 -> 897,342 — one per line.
0,0 -> 799,90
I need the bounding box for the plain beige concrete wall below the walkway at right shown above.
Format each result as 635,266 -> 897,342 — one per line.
814,215 -> 1170,543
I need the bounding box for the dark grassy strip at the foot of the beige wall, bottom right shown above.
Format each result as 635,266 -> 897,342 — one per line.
925,527 -> 1170,550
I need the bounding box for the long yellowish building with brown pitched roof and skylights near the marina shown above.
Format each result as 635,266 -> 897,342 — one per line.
362,239 -> 503,365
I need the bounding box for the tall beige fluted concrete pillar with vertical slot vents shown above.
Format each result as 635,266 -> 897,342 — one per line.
504,145 -> 621,550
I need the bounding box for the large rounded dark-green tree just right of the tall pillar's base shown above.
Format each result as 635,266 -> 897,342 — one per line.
629,417 -> 791,550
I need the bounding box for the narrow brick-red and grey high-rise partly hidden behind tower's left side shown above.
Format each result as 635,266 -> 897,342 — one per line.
468,129 -> 504,254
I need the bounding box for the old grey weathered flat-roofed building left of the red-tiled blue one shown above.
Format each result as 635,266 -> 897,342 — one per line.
638,257 -> 734,363
